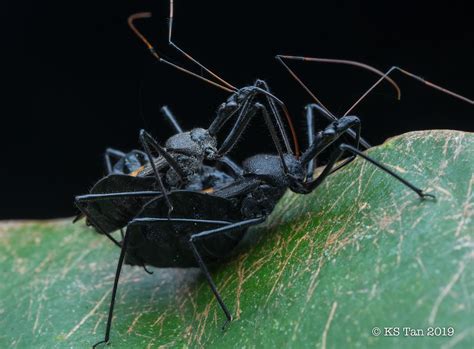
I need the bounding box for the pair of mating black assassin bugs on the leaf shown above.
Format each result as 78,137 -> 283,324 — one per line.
76,1 -> 472,345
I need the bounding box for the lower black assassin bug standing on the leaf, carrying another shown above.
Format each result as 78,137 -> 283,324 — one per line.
83,1 -> 473,347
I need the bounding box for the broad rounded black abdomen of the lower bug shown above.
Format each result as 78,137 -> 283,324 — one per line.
125,190 -> 245,268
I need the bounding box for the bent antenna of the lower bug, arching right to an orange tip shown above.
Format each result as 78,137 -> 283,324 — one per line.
277,55 -> 401,115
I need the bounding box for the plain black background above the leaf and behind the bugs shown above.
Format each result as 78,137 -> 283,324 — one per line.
0,0 -> 474,219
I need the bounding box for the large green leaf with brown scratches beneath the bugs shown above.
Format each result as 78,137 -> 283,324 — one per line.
0,131 -> 474,348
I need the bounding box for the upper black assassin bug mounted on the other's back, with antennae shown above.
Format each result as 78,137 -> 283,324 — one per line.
76,1 -> 404,251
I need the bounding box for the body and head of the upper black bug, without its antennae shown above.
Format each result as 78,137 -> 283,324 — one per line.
75,85 -> 296,246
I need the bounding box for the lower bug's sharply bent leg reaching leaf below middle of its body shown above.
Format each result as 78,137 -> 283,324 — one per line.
189,217 -> 265,329
